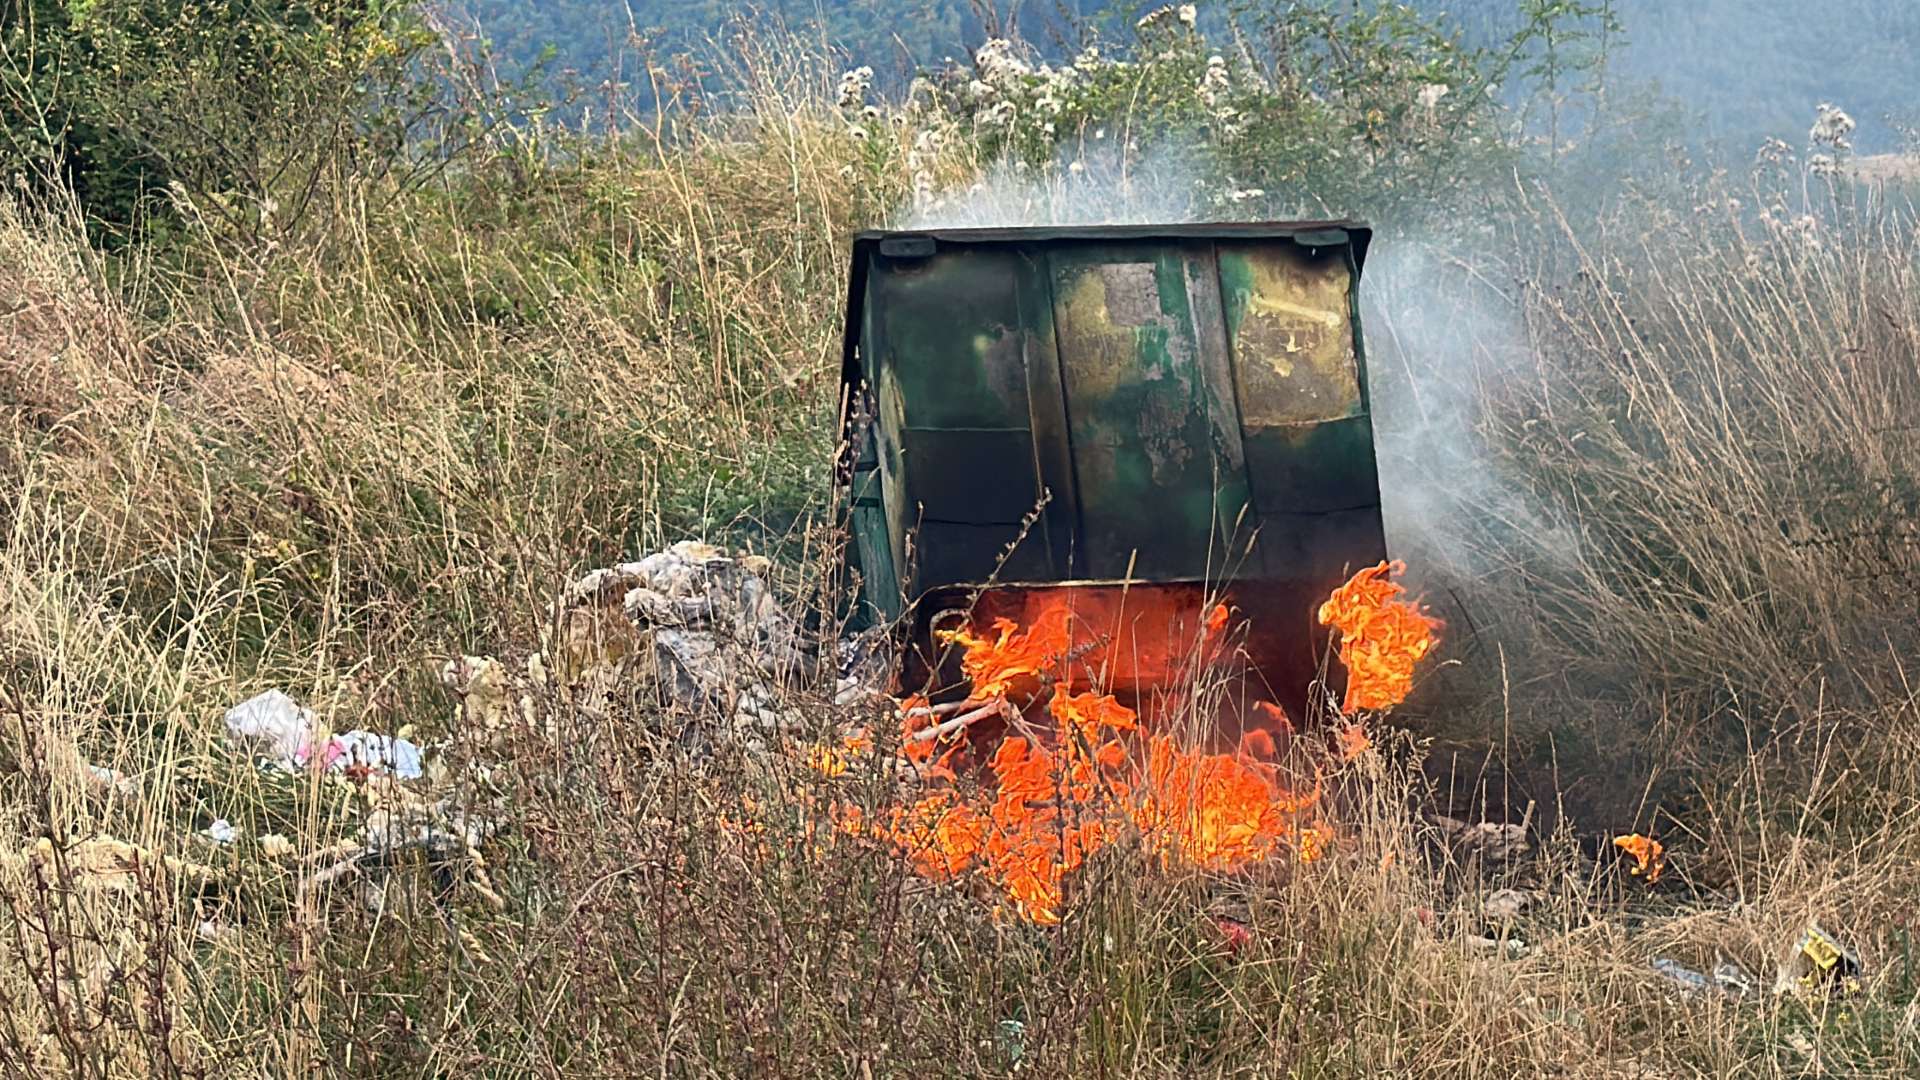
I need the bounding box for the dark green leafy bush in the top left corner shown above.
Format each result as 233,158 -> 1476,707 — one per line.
0,0 -> 468,240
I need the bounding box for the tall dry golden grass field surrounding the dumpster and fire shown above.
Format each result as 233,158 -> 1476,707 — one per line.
0,58 -> 1920,1078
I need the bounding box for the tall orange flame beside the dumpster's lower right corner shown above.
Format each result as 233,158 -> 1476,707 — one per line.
1319,561 -> 1440,713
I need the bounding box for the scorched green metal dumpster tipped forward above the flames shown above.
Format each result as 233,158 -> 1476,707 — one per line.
843,221 -> 1386,699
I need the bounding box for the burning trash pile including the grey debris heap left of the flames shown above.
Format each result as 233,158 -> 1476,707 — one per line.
432,542 -> 1438,924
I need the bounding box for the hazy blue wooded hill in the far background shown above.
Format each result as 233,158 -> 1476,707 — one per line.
447,0 -> 1920,152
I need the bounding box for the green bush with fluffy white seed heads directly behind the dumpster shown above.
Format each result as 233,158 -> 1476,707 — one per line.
841,4 -> 1628,227
